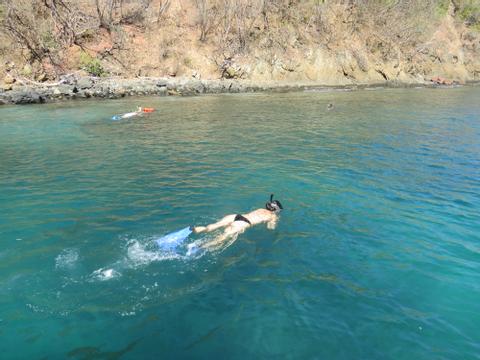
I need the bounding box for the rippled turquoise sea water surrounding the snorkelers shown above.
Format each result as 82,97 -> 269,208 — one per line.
0,88 -> 480,359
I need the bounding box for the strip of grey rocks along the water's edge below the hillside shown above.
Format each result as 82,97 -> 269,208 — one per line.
0,76 -> 480,105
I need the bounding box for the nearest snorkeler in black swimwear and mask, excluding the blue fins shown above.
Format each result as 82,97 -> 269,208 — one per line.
192,194 -> 283,248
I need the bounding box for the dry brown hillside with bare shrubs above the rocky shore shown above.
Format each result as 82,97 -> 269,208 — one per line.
0,0 -> 480,86
